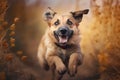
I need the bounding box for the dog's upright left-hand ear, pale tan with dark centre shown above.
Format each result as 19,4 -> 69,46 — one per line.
44,7 -> 56,24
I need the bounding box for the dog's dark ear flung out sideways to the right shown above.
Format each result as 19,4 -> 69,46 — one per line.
70,9 -> 89,23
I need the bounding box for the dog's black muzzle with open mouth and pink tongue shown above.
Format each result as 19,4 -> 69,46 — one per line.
54,27 -> 73,46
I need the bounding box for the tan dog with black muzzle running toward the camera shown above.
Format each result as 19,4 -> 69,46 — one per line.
38,7 -> 89,80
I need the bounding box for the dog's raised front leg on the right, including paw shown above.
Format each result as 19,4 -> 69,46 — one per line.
68,53 -> 82,77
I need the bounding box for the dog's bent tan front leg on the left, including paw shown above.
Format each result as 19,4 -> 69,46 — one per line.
46,55 -> 66,75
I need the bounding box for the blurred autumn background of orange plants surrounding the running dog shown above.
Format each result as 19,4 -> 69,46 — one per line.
0,0 -> 120,80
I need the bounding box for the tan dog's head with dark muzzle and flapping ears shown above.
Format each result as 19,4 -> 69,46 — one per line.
44,8 -> 89,46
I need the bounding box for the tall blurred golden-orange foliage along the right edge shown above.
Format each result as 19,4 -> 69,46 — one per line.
91,0 -> 120,80
